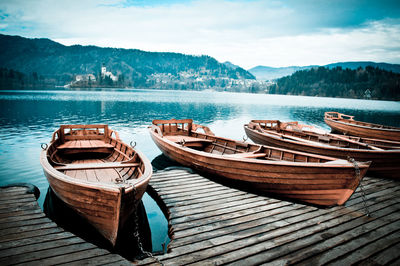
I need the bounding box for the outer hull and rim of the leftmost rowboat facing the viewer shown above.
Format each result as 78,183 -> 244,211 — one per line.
41,124 -> 152,246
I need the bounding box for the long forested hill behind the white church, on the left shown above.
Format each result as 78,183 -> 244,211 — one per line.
0,35 -> 255,89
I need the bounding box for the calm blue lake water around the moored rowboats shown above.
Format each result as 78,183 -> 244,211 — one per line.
0,89 -> 400,254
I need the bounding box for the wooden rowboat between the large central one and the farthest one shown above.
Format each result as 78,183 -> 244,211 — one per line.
244,120 -> 400,178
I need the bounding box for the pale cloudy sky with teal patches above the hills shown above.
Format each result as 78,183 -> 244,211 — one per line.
0,0 -> 400,69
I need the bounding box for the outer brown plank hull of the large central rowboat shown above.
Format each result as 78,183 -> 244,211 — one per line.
150,119 -> 369,206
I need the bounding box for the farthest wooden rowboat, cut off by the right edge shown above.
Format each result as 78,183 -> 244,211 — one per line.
324,112 -> 400,141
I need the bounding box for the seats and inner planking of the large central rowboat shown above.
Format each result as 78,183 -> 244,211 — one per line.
153,119 -> 335,163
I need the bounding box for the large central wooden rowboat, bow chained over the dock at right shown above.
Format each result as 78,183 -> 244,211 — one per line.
149,119 -> 370,206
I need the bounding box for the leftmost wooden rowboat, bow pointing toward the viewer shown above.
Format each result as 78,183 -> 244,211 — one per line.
40,125 -> 152,246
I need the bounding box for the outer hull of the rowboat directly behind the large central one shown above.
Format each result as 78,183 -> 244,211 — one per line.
244,125 -> 400,179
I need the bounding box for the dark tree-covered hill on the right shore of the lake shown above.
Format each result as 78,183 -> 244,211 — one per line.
269,66 -> 400,101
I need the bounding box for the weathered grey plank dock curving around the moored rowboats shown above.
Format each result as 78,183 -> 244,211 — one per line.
0,169 -> 400,265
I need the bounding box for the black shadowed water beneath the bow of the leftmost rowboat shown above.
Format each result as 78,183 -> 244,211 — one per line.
43,187 -> 152,260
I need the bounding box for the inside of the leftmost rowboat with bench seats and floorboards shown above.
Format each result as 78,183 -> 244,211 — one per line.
47,125 -> 144,183
